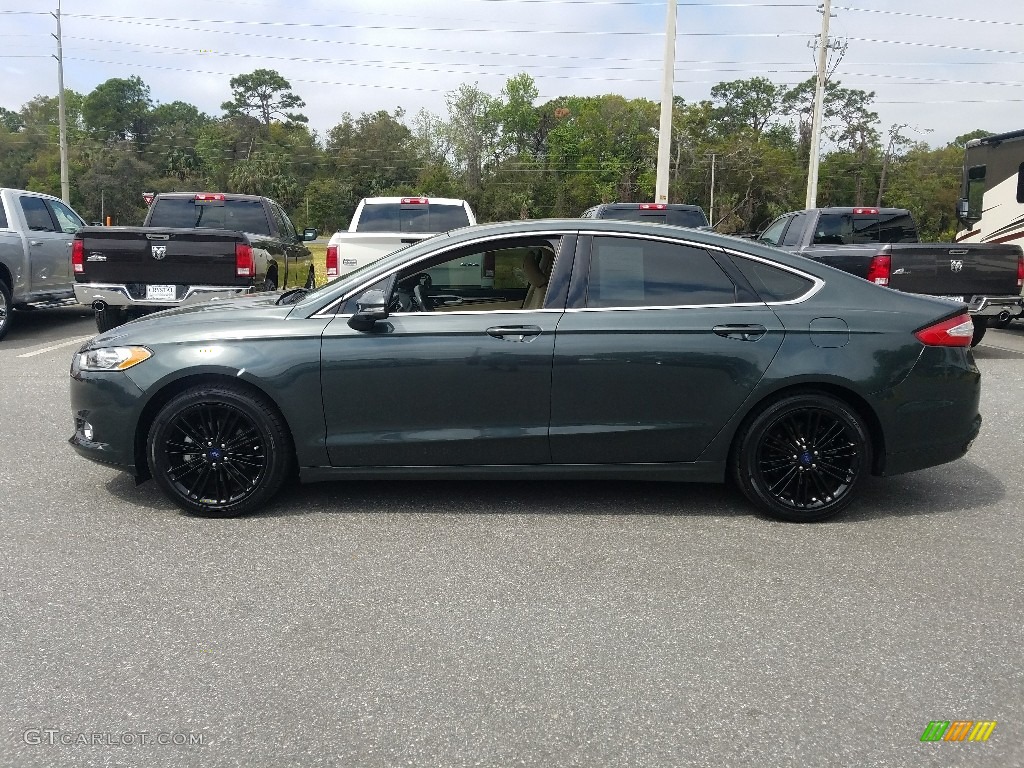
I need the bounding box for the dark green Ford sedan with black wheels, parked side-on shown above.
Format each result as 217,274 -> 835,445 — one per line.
71,219 -> 981,521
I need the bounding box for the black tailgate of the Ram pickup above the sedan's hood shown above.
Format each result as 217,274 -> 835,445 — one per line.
76,226 -> 251,286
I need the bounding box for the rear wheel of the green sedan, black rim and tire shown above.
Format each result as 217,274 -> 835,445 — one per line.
732,392 -> 871,522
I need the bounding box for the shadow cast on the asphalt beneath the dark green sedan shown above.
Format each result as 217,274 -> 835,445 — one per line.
106,459 -> 1006,524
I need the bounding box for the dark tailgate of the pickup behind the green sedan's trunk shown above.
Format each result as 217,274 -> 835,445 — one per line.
886,243 -> 1021,300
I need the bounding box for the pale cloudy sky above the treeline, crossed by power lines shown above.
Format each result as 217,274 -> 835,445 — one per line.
0,0 -> 1024,146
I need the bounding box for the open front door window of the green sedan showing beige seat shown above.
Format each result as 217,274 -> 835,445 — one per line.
391,239 -> 558,312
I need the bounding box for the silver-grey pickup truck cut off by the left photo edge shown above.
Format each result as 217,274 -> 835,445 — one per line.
0,188 -> 85,339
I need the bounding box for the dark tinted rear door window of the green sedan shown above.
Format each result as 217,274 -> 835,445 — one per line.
587,237 -> 753,307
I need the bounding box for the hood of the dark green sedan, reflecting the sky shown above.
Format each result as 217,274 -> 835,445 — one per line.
87,293 -> 295,348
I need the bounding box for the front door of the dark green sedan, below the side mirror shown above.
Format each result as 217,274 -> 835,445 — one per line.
322,236 -> 571,466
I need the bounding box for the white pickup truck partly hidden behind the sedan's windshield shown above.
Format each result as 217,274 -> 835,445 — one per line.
327,198 -> 476,280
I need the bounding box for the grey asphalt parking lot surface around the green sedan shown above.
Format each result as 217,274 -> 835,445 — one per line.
0,307 -> 1024,766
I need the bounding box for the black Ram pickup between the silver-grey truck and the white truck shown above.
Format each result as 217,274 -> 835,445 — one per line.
72,193 -> 316,332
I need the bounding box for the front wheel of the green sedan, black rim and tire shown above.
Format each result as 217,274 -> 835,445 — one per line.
146,384 -> 293,517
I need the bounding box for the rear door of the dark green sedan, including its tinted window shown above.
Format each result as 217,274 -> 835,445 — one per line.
551,234 -> 783,464
